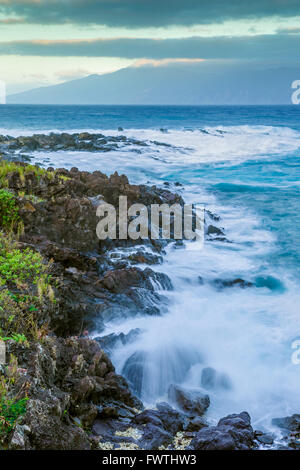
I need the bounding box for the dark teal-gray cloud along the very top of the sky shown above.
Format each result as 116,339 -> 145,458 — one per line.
0,0 -> 300,28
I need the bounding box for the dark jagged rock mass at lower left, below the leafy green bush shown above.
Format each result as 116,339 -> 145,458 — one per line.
8,337 -> 142,450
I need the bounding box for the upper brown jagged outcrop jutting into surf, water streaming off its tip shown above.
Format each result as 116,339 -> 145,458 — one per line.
4,164 -> 178,336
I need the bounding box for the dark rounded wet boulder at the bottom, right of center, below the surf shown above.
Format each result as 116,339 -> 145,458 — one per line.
190,411 -> 254,450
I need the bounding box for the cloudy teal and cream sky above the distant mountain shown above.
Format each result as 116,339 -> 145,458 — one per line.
0,0 -> 300,93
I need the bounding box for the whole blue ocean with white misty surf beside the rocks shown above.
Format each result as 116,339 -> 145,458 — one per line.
0,106 -> 300,427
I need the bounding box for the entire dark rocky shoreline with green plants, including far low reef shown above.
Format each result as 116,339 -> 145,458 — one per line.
0,133 -> 300,450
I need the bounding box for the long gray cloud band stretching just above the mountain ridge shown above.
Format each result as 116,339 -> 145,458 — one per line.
0,34 -> 300,62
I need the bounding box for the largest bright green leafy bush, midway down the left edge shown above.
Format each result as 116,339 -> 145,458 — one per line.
0,232 -> 55,342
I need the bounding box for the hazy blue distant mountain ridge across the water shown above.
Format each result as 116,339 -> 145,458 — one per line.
7,62 -> 300,105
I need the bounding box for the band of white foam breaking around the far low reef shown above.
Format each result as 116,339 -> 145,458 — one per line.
0,126 -> 300,168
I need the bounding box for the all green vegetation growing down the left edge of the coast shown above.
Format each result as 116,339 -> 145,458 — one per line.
0,160 -> 61,449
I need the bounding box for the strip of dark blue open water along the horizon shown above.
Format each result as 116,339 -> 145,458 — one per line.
0,105 -> 300,131
